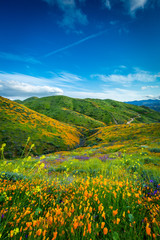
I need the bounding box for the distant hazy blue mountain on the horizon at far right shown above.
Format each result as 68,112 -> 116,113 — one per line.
126,99 -> 160,112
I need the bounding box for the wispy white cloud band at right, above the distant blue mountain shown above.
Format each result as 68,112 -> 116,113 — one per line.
91,70 -> 160,85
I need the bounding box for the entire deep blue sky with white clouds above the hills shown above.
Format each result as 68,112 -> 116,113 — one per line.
0,0 -> 160,101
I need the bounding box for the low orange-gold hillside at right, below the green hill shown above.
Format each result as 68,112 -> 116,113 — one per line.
86,123 -> 160,154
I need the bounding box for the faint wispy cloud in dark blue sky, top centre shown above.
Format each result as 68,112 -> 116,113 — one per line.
43,0 -> 88,29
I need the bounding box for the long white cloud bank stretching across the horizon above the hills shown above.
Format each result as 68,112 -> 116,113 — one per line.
0,70 -> 160,101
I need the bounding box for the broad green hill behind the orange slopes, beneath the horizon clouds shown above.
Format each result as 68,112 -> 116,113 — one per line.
16,96 -> 160,128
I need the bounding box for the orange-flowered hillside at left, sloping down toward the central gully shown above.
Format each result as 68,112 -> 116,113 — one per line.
0,97 -> 80,157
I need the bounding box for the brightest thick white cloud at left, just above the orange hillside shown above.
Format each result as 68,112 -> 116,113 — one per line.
0,72 -> 85,99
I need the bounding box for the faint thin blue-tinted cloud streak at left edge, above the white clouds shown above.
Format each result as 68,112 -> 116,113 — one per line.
0,52 -> 41,64
